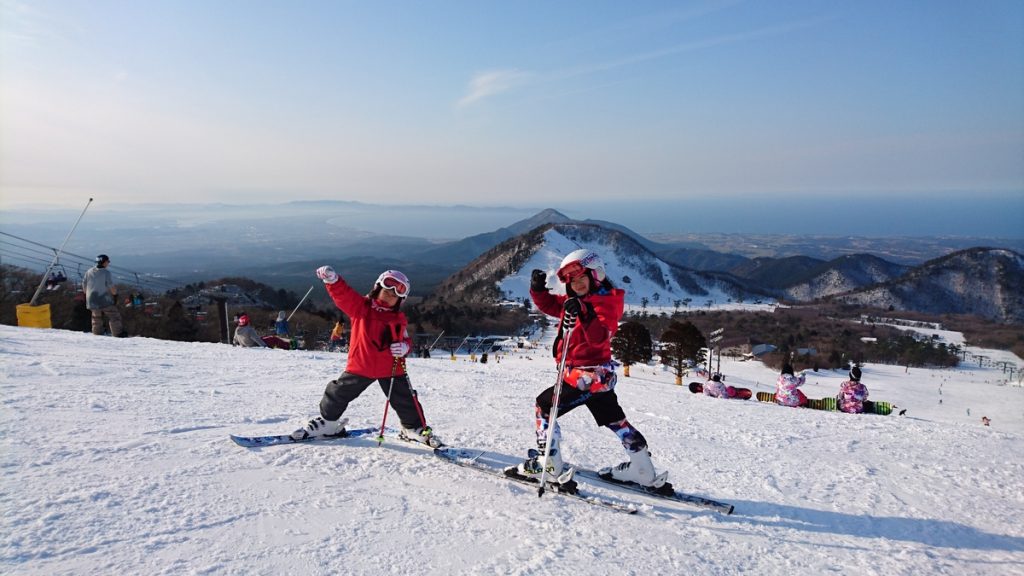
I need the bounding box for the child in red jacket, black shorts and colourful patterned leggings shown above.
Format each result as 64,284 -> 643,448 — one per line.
516,250 -> 668,486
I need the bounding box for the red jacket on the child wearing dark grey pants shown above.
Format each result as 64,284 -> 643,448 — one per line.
325,278 -> 413,379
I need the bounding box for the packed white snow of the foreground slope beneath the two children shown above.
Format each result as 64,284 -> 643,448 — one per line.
0,326 -> 1024,576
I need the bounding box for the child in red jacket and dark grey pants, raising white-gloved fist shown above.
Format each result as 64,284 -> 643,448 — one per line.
292,266 -> 443,447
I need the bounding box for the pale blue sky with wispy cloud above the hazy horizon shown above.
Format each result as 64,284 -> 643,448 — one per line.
0,0 -> 1024,236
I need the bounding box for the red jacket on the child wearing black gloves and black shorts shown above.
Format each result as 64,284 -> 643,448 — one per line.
529,288 -> 626,367
